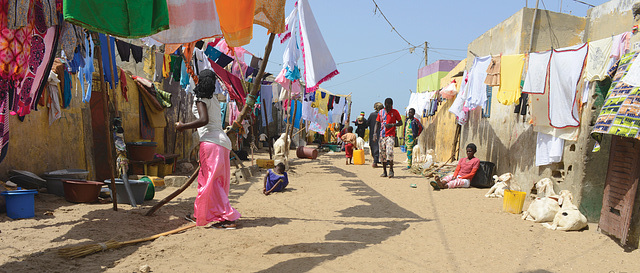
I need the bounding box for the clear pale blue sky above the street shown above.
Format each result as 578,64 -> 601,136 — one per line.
244,0 -> 608,120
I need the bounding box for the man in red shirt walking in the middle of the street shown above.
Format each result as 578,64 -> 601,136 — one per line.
373,98 -> 402,178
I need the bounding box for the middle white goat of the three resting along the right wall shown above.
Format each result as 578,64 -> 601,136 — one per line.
522,178 -> 560,223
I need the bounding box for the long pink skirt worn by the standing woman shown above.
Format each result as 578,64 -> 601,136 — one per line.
193,142 -> 240,226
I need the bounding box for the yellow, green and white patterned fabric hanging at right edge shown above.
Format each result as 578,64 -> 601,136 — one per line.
592,53 -> 640,139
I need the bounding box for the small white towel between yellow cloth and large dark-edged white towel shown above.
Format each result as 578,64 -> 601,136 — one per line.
522,50 -> 551,94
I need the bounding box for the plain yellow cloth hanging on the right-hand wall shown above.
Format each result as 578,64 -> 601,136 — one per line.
496,54 -> 524,105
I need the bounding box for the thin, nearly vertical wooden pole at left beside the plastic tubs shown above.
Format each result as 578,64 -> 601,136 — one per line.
92,33 -> 118,211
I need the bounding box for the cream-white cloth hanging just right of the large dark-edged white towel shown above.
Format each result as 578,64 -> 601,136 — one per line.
585,37 -> 613,81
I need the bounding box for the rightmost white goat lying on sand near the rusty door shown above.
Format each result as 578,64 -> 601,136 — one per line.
542,190 -> 587,231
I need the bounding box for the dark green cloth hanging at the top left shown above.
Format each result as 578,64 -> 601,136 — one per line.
62,0 -> 169,38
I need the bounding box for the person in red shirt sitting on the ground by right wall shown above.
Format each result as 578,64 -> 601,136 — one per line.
429,143 -> 480,191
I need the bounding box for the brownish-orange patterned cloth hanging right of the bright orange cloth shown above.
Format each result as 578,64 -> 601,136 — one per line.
253,0 -> 287,33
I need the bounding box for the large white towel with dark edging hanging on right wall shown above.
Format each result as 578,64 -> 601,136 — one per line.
549,44 -> 588,128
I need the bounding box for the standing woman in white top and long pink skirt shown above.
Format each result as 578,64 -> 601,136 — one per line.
176,70 -> 240,229
